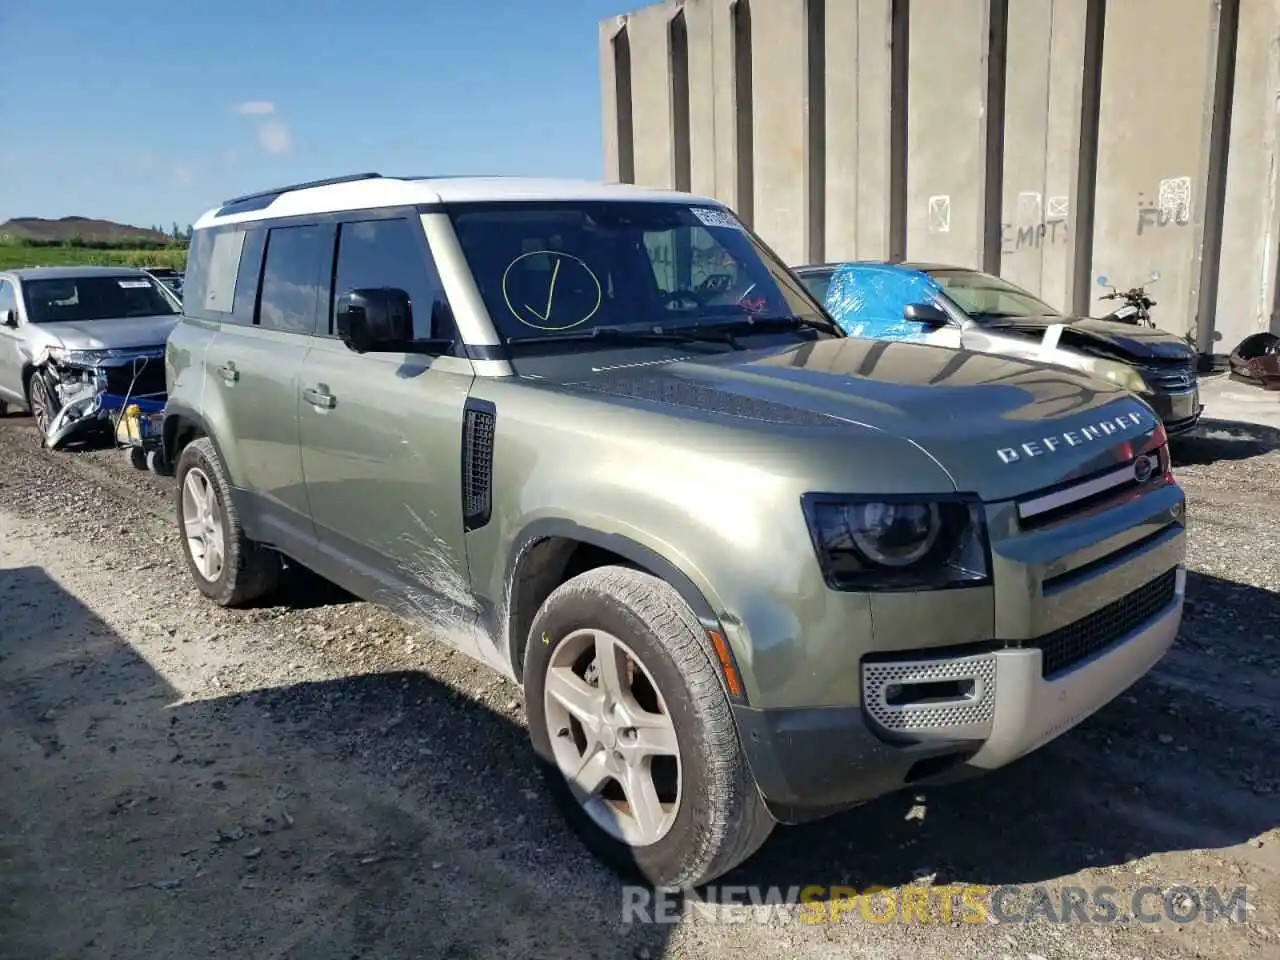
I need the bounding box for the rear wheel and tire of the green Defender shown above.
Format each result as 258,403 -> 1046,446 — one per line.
177,436 -> 283,607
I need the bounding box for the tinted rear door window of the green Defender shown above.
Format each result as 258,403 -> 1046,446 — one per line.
257,224 -> 333,334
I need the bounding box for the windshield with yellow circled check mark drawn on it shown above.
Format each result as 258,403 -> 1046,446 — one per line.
452,201 -> 831,342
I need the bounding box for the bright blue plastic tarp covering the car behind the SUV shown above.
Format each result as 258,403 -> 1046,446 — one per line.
826,264 -> 941,340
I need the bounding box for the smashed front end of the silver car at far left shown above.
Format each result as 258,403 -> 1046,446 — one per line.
35,346 -> 165,449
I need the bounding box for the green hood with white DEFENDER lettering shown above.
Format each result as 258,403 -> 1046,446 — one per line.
539,338 -> 1160,502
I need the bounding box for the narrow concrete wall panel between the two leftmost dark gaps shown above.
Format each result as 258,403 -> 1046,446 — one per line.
627,4 -> 676,189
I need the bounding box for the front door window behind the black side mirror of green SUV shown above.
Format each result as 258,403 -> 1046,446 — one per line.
328,218 -> 452,339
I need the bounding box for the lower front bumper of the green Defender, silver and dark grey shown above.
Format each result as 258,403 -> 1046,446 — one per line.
735,563 -> 1187,823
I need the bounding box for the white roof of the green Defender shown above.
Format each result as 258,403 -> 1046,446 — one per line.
193,173 -> 721,230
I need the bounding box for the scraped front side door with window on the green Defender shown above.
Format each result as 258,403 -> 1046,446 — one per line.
301,211 -> 488,655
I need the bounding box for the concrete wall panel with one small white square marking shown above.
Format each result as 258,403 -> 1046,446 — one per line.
906,0 -> 987,266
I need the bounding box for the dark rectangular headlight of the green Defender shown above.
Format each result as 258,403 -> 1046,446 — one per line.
803,494 -> 991,590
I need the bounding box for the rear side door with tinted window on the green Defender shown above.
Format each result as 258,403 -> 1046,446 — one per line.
202,223 -> 334,562
